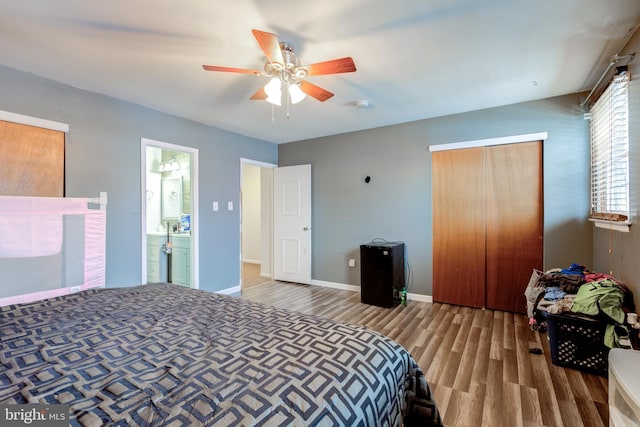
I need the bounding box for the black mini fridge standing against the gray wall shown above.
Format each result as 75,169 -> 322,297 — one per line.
360,242 -> 405,307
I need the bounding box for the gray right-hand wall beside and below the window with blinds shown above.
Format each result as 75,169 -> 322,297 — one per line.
593,32 -> 640,309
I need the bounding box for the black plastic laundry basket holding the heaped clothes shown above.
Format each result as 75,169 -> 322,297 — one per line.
541,312 -> 609,376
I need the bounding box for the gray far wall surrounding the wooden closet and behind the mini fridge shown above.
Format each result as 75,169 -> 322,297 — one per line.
278,94 -> 593,295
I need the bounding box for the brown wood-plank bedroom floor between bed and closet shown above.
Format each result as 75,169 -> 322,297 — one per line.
240,281 -> 609,427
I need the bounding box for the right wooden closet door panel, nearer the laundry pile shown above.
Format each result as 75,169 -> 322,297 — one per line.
485,141 -> 543,313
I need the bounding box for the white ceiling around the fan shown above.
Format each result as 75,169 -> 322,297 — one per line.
0,0 -> 640,143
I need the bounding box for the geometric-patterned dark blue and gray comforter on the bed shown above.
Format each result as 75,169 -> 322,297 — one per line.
0,284 -> 440,427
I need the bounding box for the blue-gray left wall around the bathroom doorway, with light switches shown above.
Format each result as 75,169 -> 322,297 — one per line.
0,66 -> 277,290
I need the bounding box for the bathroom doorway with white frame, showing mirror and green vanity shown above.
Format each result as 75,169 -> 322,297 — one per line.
141,138 -> 199,288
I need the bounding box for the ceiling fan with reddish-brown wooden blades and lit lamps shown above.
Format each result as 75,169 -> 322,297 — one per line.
202,30 -> 356,105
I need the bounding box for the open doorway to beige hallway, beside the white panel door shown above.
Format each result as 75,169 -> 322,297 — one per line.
240,159 -> 276,290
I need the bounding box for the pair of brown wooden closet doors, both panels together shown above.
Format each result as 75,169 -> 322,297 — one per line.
432,141 -> 543,312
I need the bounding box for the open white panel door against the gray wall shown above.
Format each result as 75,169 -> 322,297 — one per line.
273,165 -> 311,284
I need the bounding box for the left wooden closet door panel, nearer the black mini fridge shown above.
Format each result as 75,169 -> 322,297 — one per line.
432,147 -> 485,307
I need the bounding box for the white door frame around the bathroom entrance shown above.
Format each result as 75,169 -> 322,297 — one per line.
140,138 -> 200,289
